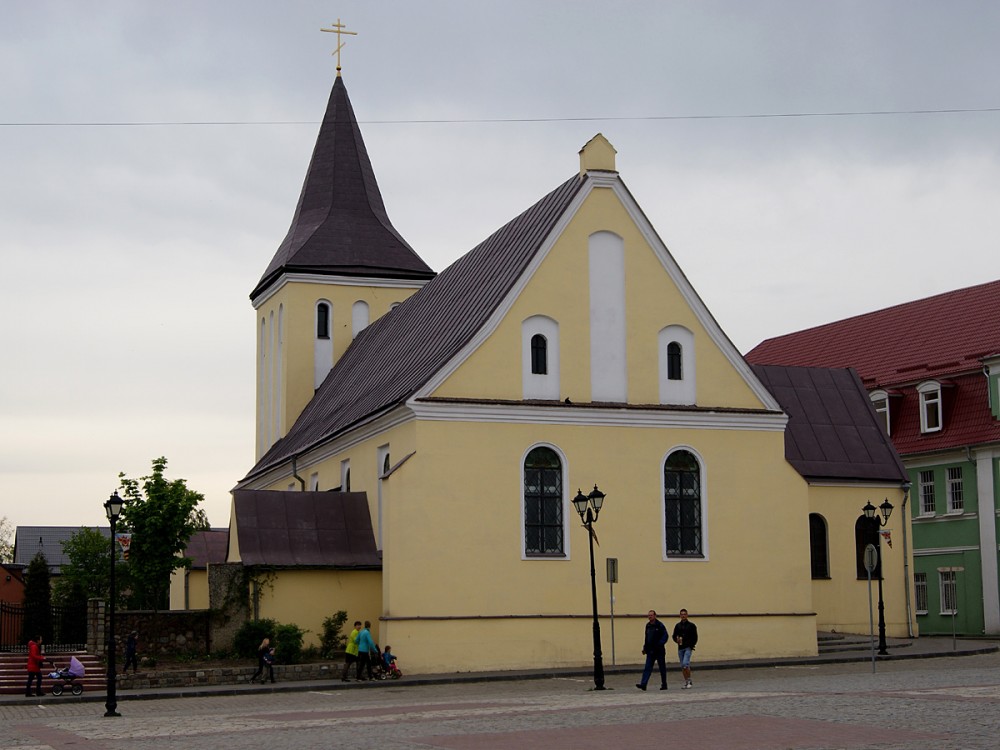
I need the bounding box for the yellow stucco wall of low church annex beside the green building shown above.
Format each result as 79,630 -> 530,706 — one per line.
809,486 -> 917,638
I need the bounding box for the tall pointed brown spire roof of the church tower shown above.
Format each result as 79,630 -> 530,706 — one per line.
250,76 -> 434,299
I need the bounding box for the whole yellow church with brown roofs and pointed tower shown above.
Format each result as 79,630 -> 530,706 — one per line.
228,64 -> 912,673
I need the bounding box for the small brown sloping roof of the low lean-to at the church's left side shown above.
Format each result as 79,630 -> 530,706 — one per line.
233,490 -> 382,569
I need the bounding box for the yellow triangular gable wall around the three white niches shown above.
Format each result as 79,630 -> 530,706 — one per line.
434,188 -> 762,409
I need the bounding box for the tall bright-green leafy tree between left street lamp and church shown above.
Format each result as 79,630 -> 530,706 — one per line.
118,456 -> 209,609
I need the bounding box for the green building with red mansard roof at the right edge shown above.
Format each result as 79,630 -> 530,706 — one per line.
746,281 -> 1000,635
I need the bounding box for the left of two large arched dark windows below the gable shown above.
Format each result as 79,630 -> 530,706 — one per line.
524,446 -> 563,555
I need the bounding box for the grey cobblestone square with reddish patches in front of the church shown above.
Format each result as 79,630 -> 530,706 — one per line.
0,654 -> 1000,750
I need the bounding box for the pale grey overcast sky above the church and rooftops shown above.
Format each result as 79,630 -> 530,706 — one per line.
0,0 -> 1000,526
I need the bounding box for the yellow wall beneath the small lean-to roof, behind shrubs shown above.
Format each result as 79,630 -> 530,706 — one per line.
258,570 -> 382,648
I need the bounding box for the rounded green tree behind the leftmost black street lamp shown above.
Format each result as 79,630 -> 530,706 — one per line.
53,526 -> 131,606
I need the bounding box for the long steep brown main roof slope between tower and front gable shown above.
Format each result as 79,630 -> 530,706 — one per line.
241,175 -> 586,478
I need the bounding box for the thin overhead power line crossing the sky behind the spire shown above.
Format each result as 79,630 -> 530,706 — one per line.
0,107 -> 1000,128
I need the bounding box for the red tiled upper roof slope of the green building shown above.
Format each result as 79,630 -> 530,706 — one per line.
746,281 -> 1000,388
